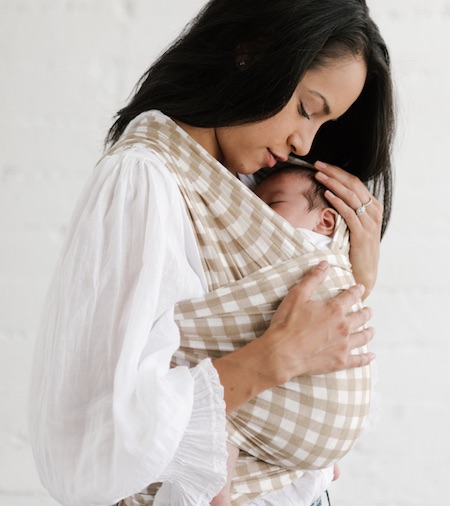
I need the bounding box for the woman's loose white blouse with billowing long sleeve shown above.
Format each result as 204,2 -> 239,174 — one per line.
29,113 -> 329,506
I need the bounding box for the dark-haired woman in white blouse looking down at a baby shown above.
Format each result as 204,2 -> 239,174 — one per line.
30,0 -> 393,506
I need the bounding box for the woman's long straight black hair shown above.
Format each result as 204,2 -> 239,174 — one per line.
107,0 -> 394,233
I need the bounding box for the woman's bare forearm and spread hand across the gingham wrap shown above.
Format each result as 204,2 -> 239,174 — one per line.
214,262 -> 374,412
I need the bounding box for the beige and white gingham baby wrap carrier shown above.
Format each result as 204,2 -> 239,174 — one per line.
113,111 -> 370,505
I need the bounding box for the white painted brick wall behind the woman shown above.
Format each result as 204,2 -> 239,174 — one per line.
0,0 -> 450,506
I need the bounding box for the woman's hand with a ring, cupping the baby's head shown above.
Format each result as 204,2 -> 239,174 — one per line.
314,162 -> 383,298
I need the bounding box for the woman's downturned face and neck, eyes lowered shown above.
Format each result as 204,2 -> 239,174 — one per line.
214,56 -> 367,174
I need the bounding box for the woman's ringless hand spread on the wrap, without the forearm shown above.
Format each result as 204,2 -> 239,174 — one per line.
260,262 -> 374,383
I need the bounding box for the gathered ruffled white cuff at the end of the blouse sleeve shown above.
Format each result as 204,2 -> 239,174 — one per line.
161,359 -> 227,506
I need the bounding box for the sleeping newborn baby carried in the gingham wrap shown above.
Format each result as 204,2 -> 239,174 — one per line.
210,165 -> 338,506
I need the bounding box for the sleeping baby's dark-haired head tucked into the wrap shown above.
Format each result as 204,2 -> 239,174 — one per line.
255,165 -> 337,236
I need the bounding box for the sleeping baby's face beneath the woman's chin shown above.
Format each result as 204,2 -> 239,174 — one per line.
255,174 -> 321,230
